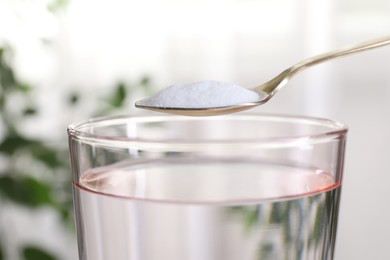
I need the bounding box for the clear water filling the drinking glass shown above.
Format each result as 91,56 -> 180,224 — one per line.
74,160 -> 340,260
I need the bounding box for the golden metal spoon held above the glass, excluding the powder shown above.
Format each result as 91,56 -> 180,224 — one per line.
135,36 -> 390,116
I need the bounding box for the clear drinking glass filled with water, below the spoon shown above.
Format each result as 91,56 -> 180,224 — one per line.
68,114 -> 347,260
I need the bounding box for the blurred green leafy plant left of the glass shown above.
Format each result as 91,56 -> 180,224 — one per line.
0,43 -> 155,260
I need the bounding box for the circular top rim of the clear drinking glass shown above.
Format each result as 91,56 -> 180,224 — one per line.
67,113 -> 348,148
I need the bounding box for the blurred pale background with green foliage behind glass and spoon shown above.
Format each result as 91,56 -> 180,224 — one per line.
0,0 -> 390,260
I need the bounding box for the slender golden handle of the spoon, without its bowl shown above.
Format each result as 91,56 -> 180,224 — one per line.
255,35 -> 390,95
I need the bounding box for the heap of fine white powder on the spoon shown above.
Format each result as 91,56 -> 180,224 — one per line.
139,81 -> 261,108
